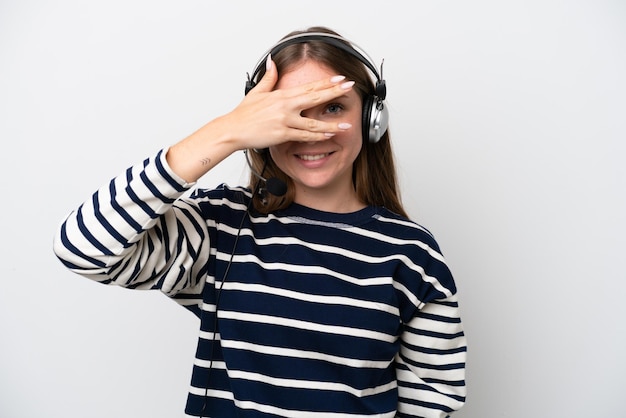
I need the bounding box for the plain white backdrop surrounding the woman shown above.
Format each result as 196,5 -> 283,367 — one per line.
0,0 -> 626,418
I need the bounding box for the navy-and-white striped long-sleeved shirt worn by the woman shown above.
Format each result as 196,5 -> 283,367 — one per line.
54,150 -> 466,418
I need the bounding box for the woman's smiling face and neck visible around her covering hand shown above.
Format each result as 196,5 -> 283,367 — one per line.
270,60 -> 362,210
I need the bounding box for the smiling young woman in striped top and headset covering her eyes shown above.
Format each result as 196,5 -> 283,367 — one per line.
54,27 -> 466,418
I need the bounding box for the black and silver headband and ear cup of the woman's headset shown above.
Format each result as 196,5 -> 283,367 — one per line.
245,32 -> 389,143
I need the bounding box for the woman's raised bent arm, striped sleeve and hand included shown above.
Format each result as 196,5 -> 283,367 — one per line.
54,59 -> 353,304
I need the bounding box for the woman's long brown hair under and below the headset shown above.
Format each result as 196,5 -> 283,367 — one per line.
248,26 -> 407,217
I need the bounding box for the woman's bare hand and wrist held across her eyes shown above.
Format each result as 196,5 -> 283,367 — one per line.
167,56 -> 354,183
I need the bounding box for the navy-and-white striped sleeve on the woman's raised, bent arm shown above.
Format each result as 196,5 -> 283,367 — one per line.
53,150 -> 209,305
